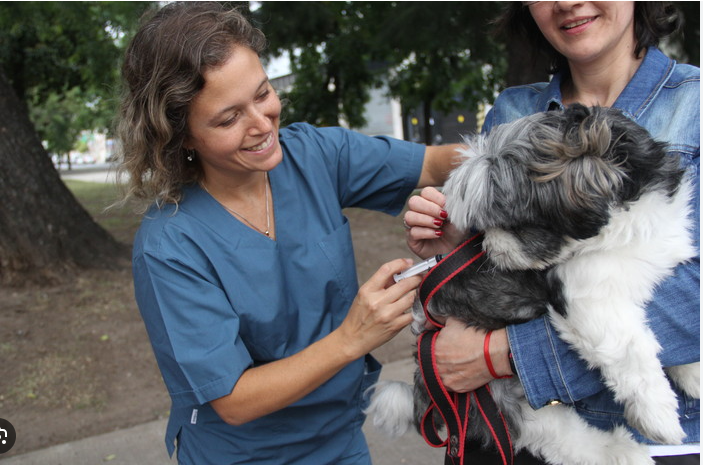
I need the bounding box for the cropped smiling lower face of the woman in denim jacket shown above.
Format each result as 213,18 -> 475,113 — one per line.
529,2 -> 635,64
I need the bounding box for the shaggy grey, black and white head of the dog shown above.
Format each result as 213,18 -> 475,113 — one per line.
444,105 -> 683,269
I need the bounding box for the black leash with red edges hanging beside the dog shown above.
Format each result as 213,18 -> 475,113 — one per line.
417,234 -> 514,465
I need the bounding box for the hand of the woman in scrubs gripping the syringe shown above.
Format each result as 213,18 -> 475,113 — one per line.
337,259 -> 422,359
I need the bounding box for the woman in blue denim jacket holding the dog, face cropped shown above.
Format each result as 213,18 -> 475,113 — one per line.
404,2 -> 700,464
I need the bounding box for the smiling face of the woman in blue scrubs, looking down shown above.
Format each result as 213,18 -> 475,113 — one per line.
184,46 -> 283,178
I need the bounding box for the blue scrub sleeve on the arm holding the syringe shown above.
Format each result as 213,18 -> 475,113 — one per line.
133,253 -> 252,407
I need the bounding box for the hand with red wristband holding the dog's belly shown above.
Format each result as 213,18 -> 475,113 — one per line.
435,318 -> 513,392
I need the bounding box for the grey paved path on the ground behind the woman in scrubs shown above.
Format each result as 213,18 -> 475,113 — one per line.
0,359 -> 444,465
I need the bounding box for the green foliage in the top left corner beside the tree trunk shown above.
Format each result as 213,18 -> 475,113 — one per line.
0,2 -> 151,153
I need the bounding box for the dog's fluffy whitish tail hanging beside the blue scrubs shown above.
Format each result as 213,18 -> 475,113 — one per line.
364,381 -> 413,437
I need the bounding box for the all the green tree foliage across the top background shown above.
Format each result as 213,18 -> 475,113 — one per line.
0,1 -> 700,147
